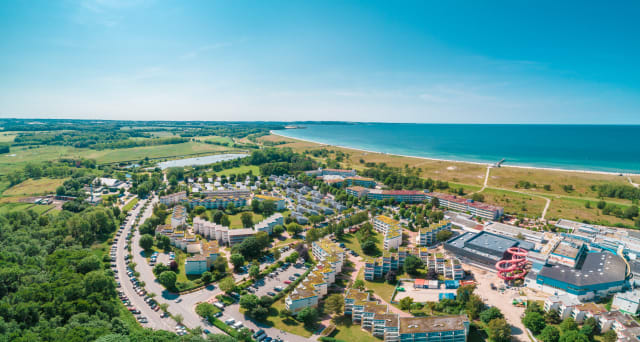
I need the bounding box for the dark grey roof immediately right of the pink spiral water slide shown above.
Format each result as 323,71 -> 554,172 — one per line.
539,253 -> 627,286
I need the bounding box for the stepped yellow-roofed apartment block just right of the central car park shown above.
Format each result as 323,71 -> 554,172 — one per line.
285,237 -> 344,313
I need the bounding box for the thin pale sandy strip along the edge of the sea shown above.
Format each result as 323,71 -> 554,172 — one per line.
269,130 -> 640,177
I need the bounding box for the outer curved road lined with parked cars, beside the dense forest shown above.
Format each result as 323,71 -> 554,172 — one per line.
116,201 -> 175,331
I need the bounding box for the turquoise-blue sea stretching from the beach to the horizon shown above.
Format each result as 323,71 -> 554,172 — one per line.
275,123 -> 640,173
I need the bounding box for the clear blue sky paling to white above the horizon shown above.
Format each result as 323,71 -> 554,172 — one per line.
0,0 -> 640,124
